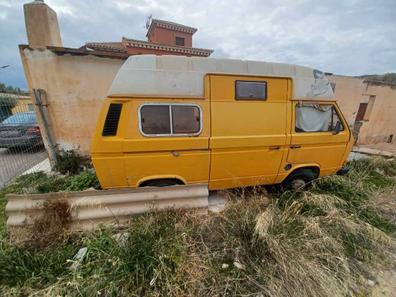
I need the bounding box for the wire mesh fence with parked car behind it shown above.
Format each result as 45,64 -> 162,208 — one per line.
0,93 -> 47,188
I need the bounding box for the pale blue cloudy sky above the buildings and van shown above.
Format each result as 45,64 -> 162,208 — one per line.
0,0 -> 396,89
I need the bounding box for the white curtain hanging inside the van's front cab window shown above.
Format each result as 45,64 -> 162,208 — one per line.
296,104 -> 332,132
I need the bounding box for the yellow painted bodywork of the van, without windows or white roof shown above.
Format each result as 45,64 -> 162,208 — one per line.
92,74 -> 353,190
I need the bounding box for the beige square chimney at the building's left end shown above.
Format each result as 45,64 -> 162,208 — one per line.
23,0 -> 63,47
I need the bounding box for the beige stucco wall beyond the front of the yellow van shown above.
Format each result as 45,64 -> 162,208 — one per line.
328,76 -> 396,144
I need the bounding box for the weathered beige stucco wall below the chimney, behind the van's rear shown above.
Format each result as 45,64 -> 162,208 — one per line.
20,48 -> 124,154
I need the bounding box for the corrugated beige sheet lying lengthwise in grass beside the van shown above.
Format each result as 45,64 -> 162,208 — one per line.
6,185 -> 209,230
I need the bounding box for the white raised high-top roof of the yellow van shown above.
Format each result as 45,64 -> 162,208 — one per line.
109,55 -> 334,100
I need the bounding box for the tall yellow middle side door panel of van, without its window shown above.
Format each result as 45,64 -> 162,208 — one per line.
209,75 -> 289,189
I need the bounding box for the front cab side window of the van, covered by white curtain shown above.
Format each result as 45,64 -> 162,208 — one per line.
296,103 -> 344,132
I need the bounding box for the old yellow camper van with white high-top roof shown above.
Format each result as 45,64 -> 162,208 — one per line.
92,55 -> 353,190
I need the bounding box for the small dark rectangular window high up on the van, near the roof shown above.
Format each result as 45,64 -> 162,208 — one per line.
235,80 -> 267,100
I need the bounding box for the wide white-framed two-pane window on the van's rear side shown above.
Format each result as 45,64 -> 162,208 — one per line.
139,104 -> 202,136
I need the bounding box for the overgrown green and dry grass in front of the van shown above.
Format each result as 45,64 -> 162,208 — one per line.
0,159 -> 396,296
